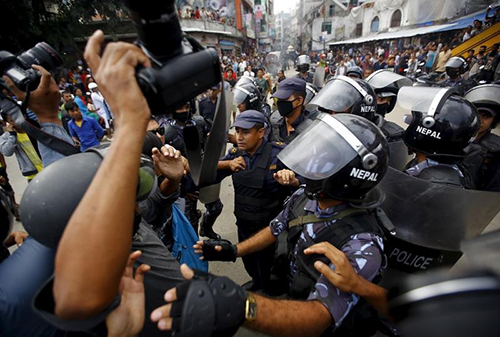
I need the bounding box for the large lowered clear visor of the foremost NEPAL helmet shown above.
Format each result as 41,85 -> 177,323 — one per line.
278,115 -> 357,180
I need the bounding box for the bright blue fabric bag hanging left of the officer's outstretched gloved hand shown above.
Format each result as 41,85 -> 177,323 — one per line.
172,204 -> 208,272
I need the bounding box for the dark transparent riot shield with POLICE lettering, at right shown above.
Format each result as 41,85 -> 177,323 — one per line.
379,167 -> 500,273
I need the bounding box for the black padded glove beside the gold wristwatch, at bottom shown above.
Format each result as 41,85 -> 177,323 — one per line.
170,270 -> 247,337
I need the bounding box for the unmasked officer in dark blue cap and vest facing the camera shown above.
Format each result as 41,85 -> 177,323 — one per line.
209,110 -> 299,290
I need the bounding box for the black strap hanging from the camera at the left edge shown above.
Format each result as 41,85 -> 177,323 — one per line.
0,91 -> 80,156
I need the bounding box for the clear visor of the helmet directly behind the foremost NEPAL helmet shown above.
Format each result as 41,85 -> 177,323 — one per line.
307,79 -> 361,112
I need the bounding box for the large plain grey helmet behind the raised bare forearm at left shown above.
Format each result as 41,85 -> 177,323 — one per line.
20,145 -> 157,248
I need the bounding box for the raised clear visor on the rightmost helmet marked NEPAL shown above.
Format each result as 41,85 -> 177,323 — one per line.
397,87 -> 447,113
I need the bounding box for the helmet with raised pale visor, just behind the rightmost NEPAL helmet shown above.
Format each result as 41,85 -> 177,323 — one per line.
366,69 -> 413,116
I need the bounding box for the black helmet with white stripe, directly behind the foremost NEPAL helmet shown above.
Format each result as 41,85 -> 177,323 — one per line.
307,76 -> 377,120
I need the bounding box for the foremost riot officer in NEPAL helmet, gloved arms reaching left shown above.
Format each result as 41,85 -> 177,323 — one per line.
160,114 -> 388,336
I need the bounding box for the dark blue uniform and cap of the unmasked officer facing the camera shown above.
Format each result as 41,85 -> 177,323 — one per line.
216,110 -> 292,290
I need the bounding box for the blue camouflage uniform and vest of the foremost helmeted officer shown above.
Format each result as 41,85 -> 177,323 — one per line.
269,188 -> 387,336
